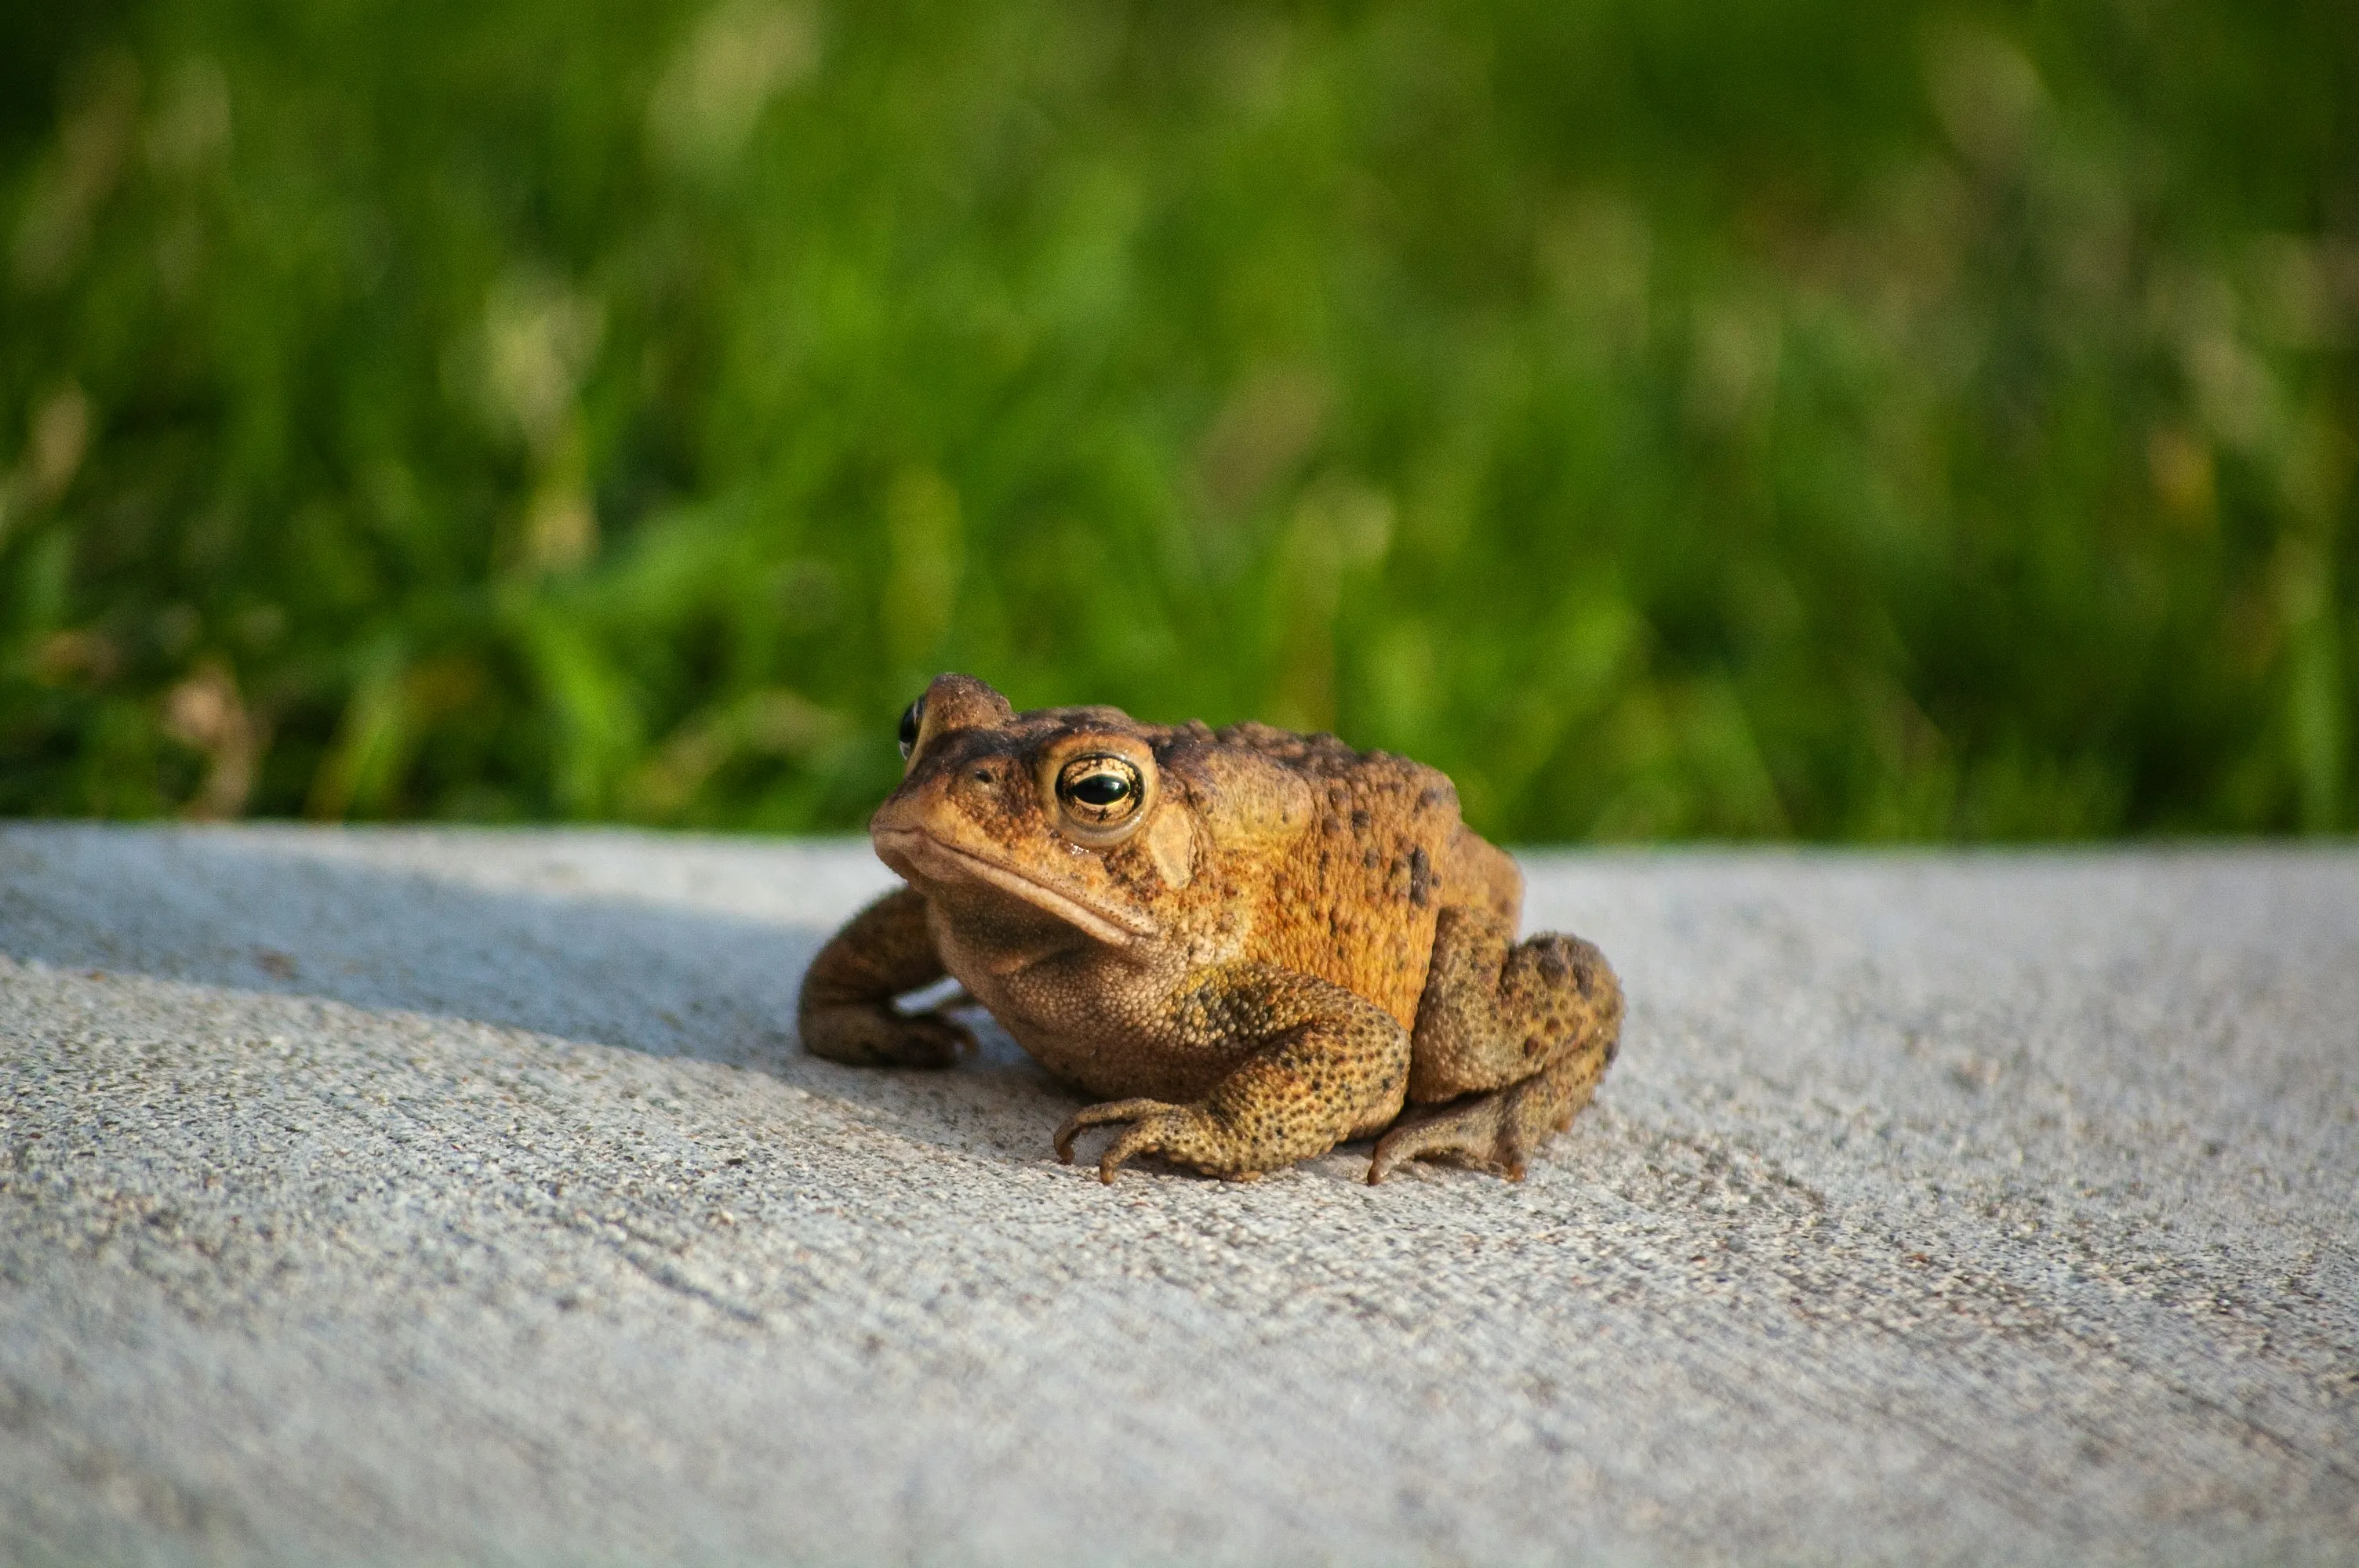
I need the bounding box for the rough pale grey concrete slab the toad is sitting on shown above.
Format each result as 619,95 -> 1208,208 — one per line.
0,826 -> 2359,1563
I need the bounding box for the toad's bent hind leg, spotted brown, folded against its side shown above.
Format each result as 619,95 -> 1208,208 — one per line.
1369,906 -> 1623,1181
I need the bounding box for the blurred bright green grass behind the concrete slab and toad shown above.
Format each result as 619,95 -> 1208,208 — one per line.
0,0 -> 2359,842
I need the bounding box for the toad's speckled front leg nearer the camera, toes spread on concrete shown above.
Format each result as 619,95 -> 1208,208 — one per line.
1057,964 -> 1408,1181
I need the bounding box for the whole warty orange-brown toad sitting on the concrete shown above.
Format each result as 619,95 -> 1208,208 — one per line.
798,674 -> 1623,1181
